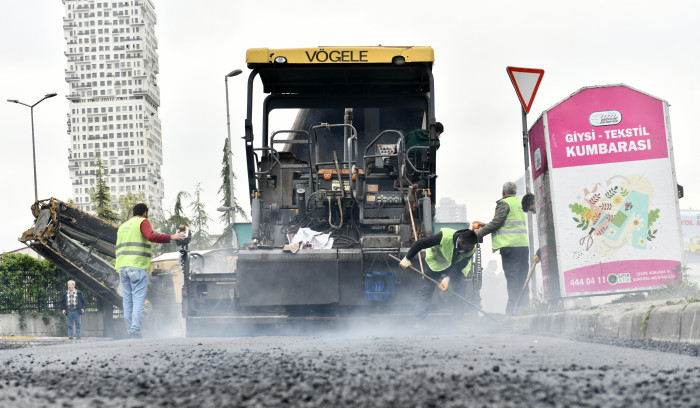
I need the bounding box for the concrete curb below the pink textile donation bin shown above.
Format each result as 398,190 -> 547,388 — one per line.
504,301 -> 700,344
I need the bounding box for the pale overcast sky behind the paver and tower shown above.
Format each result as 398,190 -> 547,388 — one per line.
0,0 -> 700,264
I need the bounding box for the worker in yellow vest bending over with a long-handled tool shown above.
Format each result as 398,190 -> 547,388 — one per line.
399,228 -> 477,320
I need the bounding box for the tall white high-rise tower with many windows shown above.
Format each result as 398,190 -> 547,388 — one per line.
63,0 -> 163,214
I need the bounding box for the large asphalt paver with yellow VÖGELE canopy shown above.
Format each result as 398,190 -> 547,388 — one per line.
183,46 -> 482,335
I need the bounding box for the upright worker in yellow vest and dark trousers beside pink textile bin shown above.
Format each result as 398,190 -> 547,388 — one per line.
477,181 -> 530,315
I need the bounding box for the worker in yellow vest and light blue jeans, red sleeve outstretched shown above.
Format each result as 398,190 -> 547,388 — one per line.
115,203 -> 187,339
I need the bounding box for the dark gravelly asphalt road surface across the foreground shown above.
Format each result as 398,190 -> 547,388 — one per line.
0,333 -> 700,407
